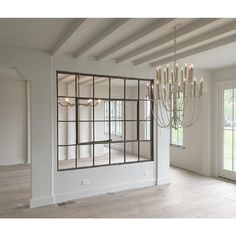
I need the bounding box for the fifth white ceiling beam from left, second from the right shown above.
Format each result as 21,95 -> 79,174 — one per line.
133,21 -> 236,65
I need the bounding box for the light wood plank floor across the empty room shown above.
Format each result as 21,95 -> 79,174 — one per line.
0,166 -> 236,218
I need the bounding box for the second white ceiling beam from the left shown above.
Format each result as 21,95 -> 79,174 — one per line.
74,18 -> 129,58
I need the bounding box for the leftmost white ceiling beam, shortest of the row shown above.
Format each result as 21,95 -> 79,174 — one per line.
51,18 -> 86,56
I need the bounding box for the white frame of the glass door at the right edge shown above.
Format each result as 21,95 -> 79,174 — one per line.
215,80 -> 236,181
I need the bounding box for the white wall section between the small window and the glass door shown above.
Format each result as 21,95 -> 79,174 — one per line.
170,70 -> 212,175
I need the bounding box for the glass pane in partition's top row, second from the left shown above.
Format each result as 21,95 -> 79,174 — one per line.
78,75 -> 93,98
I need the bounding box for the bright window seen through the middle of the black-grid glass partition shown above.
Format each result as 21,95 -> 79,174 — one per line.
105,101 -> 123,136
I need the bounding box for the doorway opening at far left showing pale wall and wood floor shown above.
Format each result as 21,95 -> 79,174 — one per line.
0,69 -> 31,215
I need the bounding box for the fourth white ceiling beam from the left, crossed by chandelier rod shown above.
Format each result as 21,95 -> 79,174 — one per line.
115,19 -> 219,63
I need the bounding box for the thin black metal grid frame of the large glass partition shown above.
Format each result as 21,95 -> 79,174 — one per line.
56,71 -> 154,171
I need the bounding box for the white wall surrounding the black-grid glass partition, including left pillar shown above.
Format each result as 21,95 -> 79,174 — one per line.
0,47 -> 169,207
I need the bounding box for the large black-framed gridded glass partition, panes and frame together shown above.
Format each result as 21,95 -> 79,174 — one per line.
57,71 -> 153,170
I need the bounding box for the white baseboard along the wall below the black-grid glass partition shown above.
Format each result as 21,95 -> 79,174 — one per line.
54,179 -> 156,203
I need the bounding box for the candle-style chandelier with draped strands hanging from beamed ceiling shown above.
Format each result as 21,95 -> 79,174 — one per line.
147,25 -> 203,129
